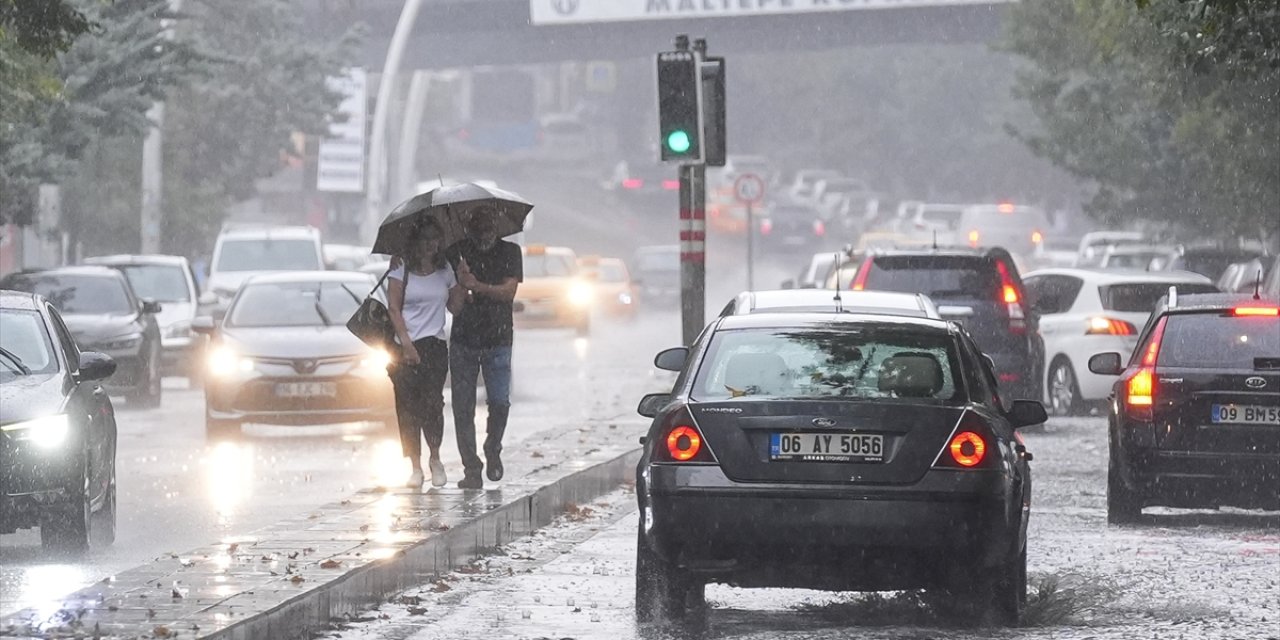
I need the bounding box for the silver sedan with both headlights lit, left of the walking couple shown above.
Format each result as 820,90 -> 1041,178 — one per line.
195,271 -> 398,438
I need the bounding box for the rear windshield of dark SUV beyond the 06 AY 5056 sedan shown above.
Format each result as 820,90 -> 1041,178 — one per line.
865,256 -> 1000,300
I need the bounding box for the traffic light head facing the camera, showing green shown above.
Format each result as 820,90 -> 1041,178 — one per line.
658,51 -> 703,163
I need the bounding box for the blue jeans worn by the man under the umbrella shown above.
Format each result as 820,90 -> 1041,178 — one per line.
449,342 -> 511,477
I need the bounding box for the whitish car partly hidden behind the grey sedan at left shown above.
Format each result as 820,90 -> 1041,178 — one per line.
84,255 -> 204,380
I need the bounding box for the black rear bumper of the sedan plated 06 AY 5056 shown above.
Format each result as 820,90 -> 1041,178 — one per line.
641,466 -> 1024,590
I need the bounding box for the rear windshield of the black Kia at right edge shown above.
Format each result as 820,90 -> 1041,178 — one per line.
1156,314 -> 1280,370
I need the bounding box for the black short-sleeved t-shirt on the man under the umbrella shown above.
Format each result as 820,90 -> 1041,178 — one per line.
445,238 -> 525,348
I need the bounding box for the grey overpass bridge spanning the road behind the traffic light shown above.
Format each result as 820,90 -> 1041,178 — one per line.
303,0 -> 1010,69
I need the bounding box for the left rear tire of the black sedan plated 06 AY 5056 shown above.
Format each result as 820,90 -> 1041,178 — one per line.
635,525 -> 707,623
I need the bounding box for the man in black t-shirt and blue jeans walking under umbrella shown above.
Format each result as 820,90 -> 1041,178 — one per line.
447,206 -> 524,489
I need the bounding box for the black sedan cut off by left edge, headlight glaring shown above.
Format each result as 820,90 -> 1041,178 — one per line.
0,291 -> 115,552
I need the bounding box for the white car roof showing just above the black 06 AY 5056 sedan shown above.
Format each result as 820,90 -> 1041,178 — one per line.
721,289 -> 942,319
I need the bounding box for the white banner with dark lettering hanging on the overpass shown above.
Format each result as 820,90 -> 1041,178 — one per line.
529,0 -> 1016,26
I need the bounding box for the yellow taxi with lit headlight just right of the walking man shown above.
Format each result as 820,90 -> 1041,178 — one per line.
515,244 -> 595,335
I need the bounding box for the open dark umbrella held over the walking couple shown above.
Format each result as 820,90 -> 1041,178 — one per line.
372,182 -> 534,255
